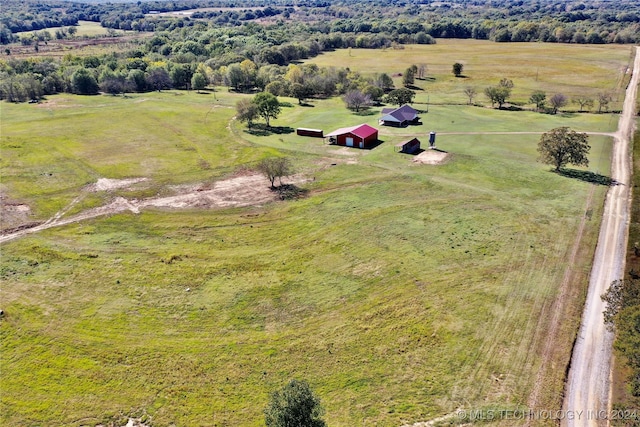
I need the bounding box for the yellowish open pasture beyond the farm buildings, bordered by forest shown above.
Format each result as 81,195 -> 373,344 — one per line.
306,39 -> 633,110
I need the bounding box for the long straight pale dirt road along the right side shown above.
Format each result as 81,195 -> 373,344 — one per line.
564,48 -> 640,427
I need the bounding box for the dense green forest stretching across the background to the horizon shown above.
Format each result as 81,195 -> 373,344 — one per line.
0,0 -> 640,101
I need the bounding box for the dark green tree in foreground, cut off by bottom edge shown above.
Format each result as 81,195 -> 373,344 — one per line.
264,380 -> 326,427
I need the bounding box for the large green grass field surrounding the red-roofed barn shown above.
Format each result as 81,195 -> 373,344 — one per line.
0,43 -> 627,427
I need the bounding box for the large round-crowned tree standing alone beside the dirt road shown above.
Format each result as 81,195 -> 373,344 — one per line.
538,126 -> 591,171
